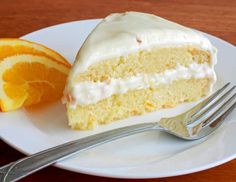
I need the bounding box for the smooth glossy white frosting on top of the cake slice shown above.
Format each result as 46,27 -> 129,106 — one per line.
70,12 -> 213,77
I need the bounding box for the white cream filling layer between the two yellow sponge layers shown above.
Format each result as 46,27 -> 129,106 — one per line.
69,63 -> 216,108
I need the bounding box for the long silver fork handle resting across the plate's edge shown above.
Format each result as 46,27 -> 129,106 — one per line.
0,123 -> 159,182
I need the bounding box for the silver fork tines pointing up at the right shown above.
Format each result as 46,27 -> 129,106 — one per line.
187,82 -> 236,127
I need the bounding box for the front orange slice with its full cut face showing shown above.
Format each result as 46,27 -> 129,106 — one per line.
0,54 -> 70,111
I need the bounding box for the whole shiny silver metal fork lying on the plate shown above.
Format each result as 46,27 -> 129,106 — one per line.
0,83 -> 236,182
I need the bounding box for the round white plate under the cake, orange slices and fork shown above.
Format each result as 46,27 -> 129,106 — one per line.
0,20 -> 236,178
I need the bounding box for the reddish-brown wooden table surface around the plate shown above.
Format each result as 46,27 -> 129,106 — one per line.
0,0 -> 236,182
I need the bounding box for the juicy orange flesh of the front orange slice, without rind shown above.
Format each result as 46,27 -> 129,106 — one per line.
2,62 -> 67,109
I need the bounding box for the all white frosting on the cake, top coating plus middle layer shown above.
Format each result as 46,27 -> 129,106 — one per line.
65,12 -> 216,107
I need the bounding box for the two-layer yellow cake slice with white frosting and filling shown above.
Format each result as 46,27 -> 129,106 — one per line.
64,12 -> 216,129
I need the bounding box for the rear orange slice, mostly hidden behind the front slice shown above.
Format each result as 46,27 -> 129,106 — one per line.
0,38 -> 70,66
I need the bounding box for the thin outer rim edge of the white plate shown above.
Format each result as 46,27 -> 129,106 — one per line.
0,19 -> 236,179
